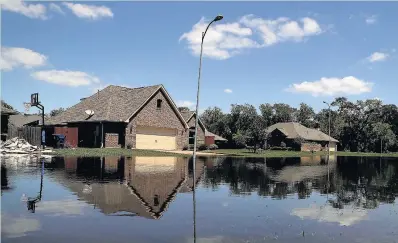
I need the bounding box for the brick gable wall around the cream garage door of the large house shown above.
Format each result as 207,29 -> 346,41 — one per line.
126,91 -> 188,150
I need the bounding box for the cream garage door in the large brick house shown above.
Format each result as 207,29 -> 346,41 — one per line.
136,127 -> 176,150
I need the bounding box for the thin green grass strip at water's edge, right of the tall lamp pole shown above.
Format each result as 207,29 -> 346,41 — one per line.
208,149 -> 398,158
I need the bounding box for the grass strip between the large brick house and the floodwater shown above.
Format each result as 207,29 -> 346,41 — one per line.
53,148 -> 186,157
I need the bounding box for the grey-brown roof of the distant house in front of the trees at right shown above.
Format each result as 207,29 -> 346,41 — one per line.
267,122 -> 339,142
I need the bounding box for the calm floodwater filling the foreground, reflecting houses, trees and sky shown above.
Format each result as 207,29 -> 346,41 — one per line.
1,156 -> 398,243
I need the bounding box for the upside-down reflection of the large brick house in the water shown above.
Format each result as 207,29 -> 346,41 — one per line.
58,157 -> 204,219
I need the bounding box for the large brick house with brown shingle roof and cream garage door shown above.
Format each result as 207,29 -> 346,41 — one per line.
46,85 -> 188,150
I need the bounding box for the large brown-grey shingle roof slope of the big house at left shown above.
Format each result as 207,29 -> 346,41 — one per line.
47,85 -> 163,125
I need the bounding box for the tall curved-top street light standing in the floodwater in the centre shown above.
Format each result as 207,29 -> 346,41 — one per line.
192,15 -> 223,242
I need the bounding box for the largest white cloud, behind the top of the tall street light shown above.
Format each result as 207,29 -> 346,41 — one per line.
179,15 -> 322,60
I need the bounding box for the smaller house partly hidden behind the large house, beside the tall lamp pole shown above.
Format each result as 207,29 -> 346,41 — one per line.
181,111 -> 227,147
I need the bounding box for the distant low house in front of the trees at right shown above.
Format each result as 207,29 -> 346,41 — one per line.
267,122 -> 339,151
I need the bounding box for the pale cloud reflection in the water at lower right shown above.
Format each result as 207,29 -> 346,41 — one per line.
291,205 -> 367,226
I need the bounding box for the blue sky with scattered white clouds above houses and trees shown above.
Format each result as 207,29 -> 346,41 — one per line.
1,0 -> 398,111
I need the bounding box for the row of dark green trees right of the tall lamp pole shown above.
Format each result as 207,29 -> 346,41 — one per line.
200,97 -> 398,152
